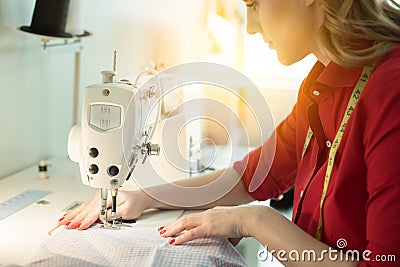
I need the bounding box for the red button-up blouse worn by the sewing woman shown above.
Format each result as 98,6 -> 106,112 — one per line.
234,46 -> 400,266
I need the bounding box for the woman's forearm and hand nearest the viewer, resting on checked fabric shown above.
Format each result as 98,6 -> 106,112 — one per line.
159,205 -> 357,266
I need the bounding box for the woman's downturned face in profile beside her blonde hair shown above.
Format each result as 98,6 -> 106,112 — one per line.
244,0 -> 323,65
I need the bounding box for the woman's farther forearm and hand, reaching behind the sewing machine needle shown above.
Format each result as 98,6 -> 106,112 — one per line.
58,168 -> 254,230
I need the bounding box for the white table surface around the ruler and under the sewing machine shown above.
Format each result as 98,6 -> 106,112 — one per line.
0,157 -> 189,266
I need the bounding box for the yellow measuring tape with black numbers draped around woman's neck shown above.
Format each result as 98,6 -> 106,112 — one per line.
302,64 -> 375,240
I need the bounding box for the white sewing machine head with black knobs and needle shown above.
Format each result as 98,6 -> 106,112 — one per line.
68,59 -> 161,229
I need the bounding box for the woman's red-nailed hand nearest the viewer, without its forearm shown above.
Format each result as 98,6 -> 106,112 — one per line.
159,206 -> 265,245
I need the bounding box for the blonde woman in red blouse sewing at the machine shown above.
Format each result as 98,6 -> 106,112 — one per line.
59,0 -> 400,266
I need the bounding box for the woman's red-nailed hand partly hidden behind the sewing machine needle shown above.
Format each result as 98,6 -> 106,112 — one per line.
58,191 -> 148,230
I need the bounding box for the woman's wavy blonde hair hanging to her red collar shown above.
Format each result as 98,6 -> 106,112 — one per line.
318,0 -> 400,66
